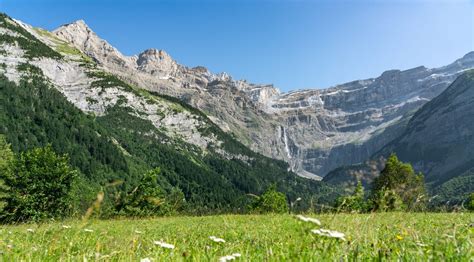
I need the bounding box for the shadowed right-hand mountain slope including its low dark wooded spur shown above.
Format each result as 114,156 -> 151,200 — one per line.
324,70 -> 474,202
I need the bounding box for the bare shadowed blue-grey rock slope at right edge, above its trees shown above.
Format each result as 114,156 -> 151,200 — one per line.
382,70 -> 474,199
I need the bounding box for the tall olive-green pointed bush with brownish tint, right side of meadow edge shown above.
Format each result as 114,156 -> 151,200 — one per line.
372,154 -> 426,210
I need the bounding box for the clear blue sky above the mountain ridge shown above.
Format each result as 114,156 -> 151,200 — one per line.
0,0 -> 474,91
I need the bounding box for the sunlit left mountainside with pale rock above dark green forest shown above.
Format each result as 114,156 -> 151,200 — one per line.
0,15 -> 334,212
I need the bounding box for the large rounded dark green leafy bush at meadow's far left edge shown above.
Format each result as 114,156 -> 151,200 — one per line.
0,146 -> 77,222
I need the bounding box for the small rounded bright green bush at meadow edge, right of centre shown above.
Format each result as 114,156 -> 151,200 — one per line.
252,185 -> 288,213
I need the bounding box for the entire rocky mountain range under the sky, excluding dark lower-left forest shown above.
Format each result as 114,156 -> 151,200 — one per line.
0,13 -> 474,207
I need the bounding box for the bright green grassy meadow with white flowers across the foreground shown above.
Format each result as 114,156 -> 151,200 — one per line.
0,213 -> 474,261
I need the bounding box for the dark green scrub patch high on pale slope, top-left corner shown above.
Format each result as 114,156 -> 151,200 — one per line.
0,13 -> 62,59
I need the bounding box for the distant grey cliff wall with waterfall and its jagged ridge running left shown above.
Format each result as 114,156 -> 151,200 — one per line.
53,21 -> 474,178
